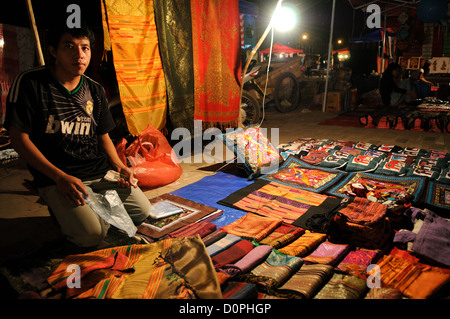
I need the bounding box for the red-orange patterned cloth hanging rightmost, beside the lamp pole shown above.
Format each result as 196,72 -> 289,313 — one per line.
191,0 -> 241,128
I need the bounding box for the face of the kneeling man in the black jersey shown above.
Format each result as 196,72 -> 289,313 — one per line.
52,33 -> 91,77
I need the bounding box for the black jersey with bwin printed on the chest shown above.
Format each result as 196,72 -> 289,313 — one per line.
5,67 -> 114,187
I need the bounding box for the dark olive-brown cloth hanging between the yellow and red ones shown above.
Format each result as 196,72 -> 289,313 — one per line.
154,0 -> 194,134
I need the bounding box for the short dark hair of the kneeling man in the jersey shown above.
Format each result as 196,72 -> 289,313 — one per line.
48,19 -> 95,49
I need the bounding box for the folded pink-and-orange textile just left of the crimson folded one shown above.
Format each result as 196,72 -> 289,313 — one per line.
303,241 -> 350,266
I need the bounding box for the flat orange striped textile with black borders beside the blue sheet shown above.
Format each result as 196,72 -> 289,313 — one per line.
219,180 -> 328,224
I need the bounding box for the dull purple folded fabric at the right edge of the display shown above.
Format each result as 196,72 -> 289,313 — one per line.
412,210 -> 450,266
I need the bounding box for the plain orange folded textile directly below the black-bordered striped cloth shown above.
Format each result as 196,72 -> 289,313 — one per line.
221,213 -> 282,241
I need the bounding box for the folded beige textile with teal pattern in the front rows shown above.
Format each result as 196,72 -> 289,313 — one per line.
236,250 -> 303,294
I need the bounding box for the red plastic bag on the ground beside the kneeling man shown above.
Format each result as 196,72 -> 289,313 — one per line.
116,124 -> 183,187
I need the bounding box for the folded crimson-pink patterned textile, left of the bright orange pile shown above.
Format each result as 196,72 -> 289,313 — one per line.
336,248 -> 382,278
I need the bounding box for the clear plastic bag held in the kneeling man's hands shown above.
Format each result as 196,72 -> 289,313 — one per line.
85,190 -> 137,237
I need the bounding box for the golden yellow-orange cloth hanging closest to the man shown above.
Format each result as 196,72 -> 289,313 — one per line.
102,0 -> 167,136
